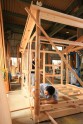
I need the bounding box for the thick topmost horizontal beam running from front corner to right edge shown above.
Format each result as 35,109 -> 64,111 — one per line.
31,5 -> 83,28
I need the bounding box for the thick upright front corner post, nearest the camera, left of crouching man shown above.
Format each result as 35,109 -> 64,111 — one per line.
34,11 -> 40,123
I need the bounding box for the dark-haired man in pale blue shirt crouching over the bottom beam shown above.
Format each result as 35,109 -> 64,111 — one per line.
32,83 -> 58,104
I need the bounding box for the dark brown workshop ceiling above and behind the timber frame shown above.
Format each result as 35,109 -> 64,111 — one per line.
2,0 -> 83,56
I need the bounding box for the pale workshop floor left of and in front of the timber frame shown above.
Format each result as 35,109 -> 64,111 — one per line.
8,90 -> 83,124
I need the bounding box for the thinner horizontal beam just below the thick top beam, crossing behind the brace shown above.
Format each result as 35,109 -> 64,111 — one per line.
40,36 -> 83,46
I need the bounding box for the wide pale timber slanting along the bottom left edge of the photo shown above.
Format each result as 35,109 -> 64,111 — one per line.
0,71 -> 12,124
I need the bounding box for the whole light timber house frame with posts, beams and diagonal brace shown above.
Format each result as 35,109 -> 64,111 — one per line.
19,5 -> 83,124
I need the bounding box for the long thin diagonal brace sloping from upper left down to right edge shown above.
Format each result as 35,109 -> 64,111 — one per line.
26,8 -> 83,86
